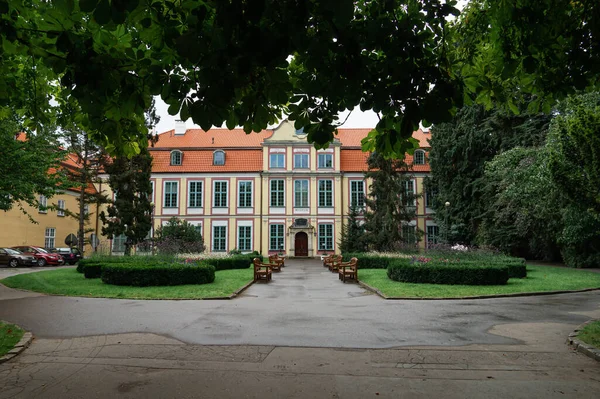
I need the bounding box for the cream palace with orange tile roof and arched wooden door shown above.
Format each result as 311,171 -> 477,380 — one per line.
135,121 -> 439,256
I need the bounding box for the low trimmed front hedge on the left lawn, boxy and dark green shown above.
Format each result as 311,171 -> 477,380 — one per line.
102,263 -> 215,287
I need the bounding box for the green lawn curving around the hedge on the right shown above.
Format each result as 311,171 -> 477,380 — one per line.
358,265 -> 600,298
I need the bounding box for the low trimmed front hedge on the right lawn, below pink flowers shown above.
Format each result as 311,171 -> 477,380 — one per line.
387,259 -> 508,285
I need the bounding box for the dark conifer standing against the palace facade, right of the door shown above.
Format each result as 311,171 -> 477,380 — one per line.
365,152 -> 418,251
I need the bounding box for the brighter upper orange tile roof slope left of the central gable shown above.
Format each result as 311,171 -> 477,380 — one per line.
154,129 -> 273,149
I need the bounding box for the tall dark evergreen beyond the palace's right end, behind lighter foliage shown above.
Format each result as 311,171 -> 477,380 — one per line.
428,106 -> 550,244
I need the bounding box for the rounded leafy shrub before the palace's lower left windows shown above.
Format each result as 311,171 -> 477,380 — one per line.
155,217 -> 205,254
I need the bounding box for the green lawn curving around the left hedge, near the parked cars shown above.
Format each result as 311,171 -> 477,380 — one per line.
0,268 -> 253,299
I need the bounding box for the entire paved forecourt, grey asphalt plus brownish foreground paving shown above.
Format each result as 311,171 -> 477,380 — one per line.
0,260 -> 600,399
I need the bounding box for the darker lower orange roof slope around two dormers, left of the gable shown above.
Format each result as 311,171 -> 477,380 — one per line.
150,147 -> 263,173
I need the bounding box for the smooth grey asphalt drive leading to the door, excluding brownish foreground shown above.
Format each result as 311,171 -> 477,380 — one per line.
0,260 -> 600,348
